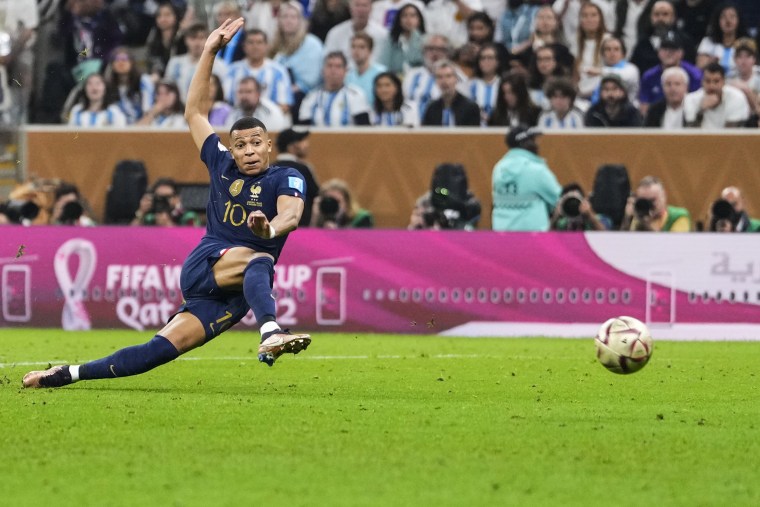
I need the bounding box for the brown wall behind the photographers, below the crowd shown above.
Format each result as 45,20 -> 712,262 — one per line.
24,128 -> 760,229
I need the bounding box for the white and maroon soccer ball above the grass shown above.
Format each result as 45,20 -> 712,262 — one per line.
594,317 -> 654,374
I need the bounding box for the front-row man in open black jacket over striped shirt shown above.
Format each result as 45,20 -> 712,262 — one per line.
422,60 -> 480,127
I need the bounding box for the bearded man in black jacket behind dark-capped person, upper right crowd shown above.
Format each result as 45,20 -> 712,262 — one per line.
630,0 -> 697,74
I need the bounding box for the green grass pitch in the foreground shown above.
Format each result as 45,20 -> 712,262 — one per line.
0,329 -> 760,507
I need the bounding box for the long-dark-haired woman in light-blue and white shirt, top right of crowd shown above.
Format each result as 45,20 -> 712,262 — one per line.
697,0 -> 747,73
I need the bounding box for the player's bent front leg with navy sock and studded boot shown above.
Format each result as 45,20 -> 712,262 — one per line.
213,247 -> 311,366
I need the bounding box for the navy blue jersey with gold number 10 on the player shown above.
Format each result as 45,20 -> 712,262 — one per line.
201,134 -> 306,261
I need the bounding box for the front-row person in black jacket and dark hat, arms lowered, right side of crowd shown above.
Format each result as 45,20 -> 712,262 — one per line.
585,74 -> 643,127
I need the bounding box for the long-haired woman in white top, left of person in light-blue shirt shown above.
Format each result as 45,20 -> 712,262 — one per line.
575,2 -> 607,99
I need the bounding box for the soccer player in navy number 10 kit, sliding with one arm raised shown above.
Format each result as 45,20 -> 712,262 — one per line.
23,18 -> 311,387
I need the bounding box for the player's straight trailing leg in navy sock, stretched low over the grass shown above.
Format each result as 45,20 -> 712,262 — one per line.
22,312 -> 206,388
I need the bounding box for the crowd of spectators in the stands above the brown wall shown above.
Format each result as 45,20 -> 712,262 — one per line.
0,0 -> 760,228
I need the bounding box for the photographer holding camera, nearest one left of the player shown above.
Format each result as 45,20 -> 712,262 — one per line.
132,178 -> 202,226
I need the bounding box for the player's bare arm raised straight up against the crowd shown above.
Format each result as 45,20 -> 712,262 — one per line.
185,18 -> 245,150
